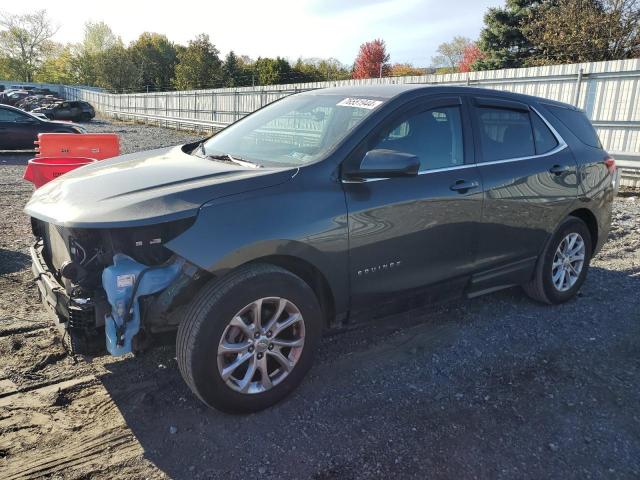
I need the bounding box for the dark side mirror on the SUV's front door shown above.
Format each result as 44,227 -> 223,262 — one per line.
348,149 -> 420,178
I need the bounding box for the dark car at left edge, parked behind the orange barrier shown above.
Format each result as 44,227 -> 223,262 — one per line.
0,105 -> 86,150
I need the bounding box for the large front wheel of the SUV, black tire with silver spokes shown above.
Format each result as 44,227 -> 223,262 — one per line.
176,264 -> 323,413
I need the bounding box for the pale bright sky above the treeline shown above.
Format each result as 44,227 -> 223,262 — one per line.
5,0 -> 504,66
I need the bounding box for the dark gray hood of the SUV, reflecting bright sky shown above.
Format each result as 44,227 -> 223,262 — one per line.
25,143 -> 297,228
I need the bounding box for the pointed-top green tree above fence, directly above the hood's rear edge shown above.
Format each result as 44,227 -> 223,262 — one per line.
175,34 -> 223,90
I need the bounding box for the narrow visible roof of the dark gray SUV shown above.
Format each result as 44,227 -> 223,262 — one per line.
303,83 -> 576,110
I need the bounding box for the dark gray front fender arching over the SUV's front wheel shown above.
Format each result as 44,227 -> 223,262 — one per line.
165,176 -> 349,313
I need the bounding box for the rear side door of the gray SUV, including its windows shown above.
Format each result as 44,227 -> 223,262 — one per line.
471,97 -> 578,276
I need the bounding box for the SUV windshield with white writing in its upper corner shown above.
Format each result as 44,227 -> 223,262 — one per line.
202,94 -> 382,166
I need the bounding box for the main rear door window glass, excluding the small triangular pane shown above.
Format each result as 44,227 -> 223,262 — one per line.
477,107 -> 536,162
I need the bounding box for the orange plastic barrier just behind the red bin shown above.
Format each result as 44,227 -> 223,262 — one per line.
35,133 -> 120,160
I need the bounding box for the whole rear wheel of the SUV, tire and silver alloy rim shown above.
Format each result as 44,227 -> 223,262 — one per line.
524,217 -> 592,304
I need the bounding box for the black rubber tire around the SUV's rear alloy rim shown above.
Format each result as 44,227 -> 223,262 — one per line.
523,217 -> 593,305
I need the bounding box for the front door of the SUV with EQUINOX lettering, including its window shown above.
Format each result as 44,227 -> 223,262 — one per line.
343,97 -> 482,308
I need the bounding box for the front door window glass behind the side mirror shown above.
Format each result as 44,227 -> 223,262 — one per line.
373,106 -> 464,172
